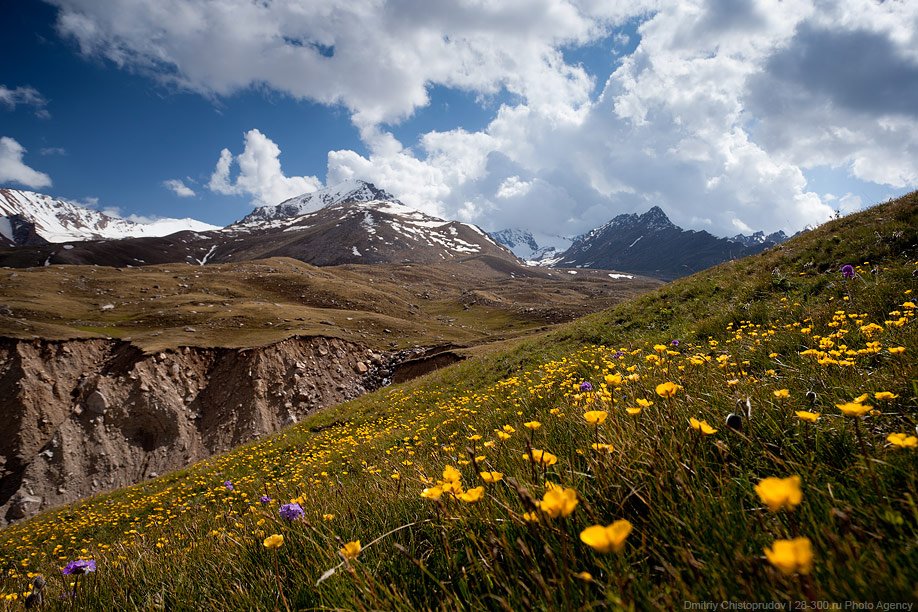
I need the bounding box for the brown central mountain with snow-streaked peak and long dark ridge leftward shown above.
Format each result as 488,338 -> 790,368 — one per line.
0,181 -> 519,267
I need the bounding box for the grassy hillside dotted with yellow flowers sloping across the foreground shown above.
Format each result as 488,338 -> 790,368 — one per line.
0,194 -> 918,609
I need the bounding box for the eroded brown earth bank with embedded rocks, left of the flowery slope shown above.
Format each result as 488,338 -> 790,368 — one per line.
0,337 -> 412,523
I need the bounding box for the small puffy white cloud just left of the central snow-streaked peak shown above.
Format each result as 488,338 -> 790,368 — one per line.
208,129 -> 322,206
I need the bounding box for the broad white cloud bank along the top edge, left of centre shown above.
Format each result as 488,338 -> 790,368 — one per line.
51,0 -> 636,125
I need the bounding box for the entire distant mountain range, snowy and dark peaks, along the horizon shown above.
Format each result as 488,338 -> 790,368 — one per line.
0,180 -> 787,280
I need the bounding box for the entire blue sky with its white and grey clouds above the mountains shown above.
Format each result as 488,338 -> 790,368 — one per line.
0,0 -> 918,237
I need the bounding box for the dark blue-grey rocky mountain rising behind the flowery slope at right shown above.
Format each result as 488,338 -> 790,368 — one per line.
553,206 -> 786,280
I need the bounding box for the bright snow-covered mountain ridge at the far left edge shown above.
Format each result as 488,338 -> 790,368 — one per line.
0,189 -> 217,246
